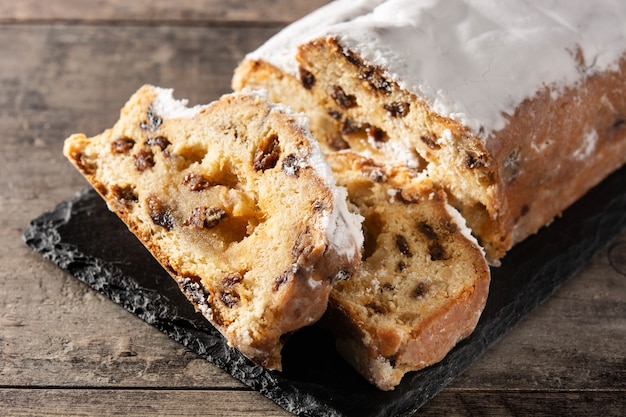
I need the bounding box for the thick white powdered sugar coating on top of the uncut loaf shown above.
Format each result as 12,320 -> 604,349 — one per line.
249,0 -> 626,140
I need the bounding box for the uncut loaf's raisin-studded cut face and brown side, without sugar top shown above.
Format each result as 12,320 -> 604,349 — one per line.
233,38 -> 626,263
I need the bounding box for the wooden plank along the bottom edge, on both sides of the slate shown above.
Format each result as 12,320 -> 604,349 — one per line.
0,388 -> 626,417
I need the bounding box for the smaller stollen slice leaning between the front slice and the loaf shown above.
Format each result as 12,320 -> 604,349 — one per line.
323,152 -> 490,390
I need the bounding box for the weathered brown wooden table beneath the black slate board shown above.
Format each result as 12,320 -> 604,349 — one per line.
0,0 -> 626,416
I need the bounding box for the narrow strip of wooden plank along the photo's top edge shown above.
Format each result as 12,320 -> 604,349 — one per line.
0,0 -> 329,25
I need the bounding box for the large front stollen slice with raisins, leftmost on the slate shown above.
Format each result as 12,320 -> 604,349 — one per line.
64,85 -> 363,369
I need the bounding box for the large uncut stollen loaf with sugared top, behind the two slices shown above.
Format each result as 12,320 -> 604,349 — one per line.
233,0 -> 626,263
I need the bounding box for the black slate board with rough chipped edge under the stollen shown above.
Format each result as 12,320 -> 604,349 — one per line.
24,167 -> 626,417
